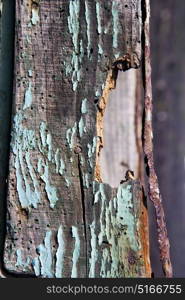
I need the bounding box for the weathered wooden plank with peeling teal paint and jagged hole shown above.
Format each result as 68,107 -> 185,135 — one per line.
4,0 -> 150,278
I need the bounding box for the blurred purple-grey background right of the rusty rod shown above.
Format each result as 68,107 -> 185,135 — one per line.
150,0 -> 185,277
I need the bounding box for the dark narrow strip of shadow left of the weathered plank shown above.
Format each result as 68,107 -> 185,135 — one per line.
0,0 -> 15,277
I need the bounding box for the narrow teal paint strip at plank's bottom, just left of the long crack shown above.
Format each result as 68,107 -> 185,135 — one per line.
71,226 -> 80,278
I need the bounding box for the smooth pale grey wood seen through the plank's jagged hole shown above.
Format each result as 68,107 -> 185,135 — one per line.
100,69 -> 143,187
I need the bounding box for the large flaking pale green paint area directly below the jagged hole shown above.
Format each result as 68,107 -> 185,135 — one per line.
91,181 -> 140,278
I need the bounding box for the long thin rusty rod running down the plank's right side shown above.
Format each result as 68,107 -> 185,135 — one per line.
142,0 -> 173,277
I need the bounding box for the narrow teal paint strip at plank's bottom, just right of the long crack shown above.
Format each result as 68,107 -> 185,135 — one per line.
89,221 -> 98,278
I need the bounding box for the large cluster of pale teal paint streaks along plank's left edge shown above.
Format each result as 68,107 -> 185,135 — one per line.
11,113 -> 40,208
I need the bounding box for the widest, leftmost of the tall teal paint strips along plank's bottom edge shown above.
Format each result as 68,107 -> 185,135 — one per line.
37,231 -> 54,278
